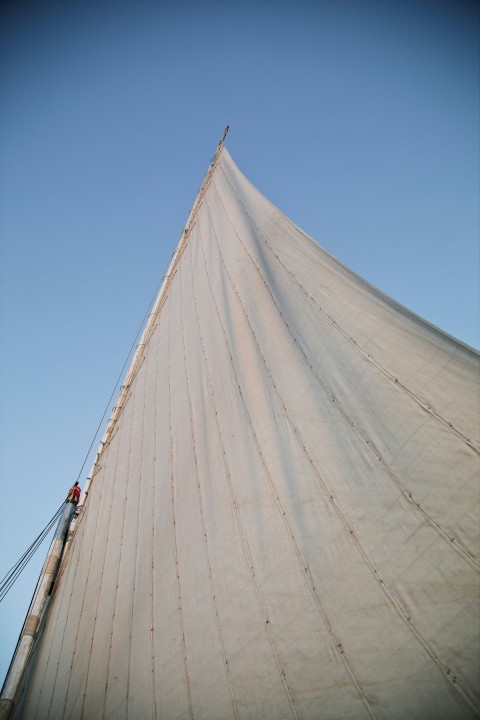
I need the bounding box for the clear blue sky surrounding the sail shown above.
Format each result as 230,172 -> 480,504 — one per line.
0,0 -> 480,681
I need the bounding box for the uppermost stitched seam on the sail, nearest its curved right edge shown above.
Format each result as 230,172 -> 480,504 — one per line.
217,165 -> 480,454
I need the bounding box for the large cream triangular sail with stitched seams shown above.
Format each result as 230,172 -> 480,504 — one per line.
15,148 -> 480,720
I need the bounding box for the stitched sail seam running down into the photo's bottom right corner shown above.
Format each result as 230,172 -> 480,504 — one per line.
204,197 -> 475,709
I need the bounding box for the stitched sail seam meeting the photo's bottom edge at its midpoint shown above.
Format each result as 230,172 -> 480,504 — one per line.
179,258 -> 239,720
